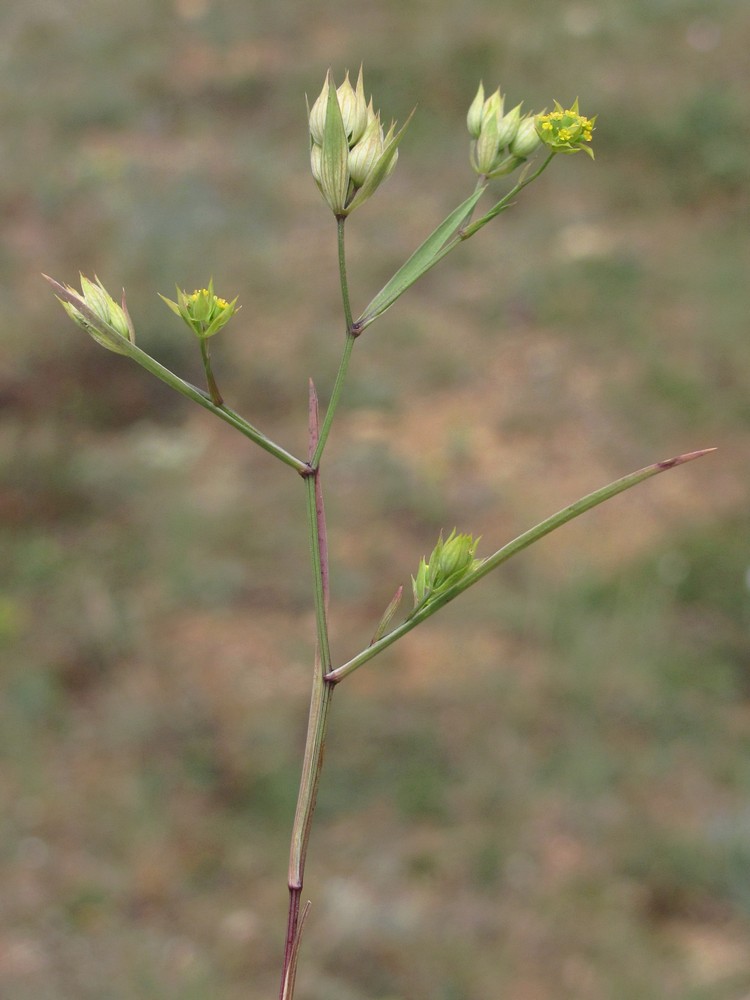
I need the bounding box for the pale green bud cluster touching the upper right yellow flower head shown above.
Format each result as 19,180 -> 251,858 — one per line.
466,83 -> 541,179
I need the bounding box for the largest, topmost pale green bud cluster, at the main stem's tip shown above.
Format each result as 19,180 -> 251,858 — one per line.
308,69 -> 403,218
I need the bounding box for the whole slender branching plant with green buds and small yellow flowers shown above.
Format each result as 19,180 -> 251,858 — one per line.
48,70 -> 713,1000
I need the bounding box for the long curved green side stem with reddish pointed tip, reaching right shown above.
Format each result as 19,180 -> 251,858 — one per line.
326,448 -> 715,684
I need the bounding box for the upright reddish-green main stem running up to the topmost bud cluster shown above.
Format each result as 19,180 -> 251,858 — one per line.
279,217 -> 356,1000
